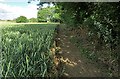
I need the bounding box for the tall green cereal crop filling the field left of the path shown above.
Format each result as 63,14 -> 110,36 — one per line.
1,24 -> 55,77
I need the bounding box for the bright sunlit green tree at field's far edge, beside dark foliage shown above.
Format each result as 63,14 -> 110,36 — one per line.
37,7 -> 60,22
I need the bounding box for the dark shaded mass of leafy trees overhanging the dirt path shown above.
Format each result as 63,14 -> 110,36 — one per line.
56,3 -> 120,49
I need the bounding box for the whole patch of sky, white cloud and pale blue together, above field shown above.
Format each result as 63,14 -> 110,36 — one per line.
0,0 -> 38,20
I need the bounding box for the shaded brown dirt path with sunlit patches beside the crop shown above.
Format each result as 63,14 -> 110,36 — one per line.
56,27 -> 106,77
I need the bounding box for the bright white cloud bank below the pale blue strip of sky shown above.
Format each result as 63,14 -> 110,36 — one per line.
0,3 -> 37,19
